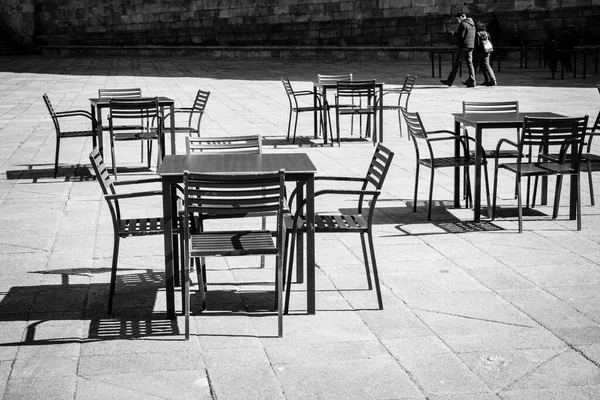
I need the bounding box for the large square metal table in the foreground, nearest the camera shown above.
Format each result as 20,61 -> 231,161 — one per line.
158,153 -> 317,319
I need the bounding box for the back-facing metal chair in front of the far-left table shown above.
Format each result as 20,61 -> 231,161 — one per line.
108,97 -> 164,179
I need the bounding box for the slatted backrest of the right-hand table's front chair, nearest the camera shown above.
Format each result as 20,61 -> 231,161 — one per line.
519,115 -> 588,162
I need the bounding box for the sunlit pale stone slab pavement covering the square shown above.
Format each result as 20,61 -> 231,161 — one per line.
0,56 -> 600,400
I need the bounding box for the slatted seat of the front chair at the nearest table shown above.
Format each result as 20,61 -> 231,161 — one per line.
190,230 -> 277,257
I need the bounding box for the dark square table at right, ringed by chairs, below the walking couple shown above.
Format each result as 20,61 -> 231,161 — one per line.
452,112 -> 575,221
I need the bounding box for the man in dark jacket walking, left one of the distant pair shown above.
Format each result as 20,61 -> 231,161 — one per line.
441,12 -> 475,87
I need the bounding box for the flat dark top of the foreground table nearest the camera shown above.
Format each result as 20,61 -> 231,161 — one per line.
157,153 -> 317,180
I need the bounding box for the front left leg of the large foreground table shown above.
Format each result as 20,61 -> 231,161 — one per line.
162,179 -> 175,319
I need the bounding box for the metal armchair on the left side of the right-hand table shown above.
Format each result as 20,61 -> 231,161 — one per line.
400,109 -> 490,220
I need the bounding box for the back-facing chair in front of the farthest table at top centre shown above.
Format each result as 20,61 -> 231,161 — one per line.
335,80 -> 377,145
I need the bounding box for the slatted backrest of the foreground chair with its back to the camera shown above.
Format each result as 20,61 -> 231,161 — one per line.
183,170 -> 285,223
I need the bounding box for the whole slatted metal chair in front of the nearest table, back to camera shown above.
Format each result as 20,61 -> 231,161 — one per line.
181,170 -> 285,339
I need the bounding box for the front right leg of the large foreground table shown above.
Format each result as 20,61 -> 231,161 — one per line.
306,175 -> 316,314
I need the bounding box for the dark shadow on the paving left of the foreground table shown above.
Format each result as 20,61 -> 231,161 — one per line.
0,268 -> 180,347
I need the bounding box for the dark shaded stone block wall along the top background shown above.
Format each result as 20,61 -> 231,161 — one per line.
0,0 -> 600,47
